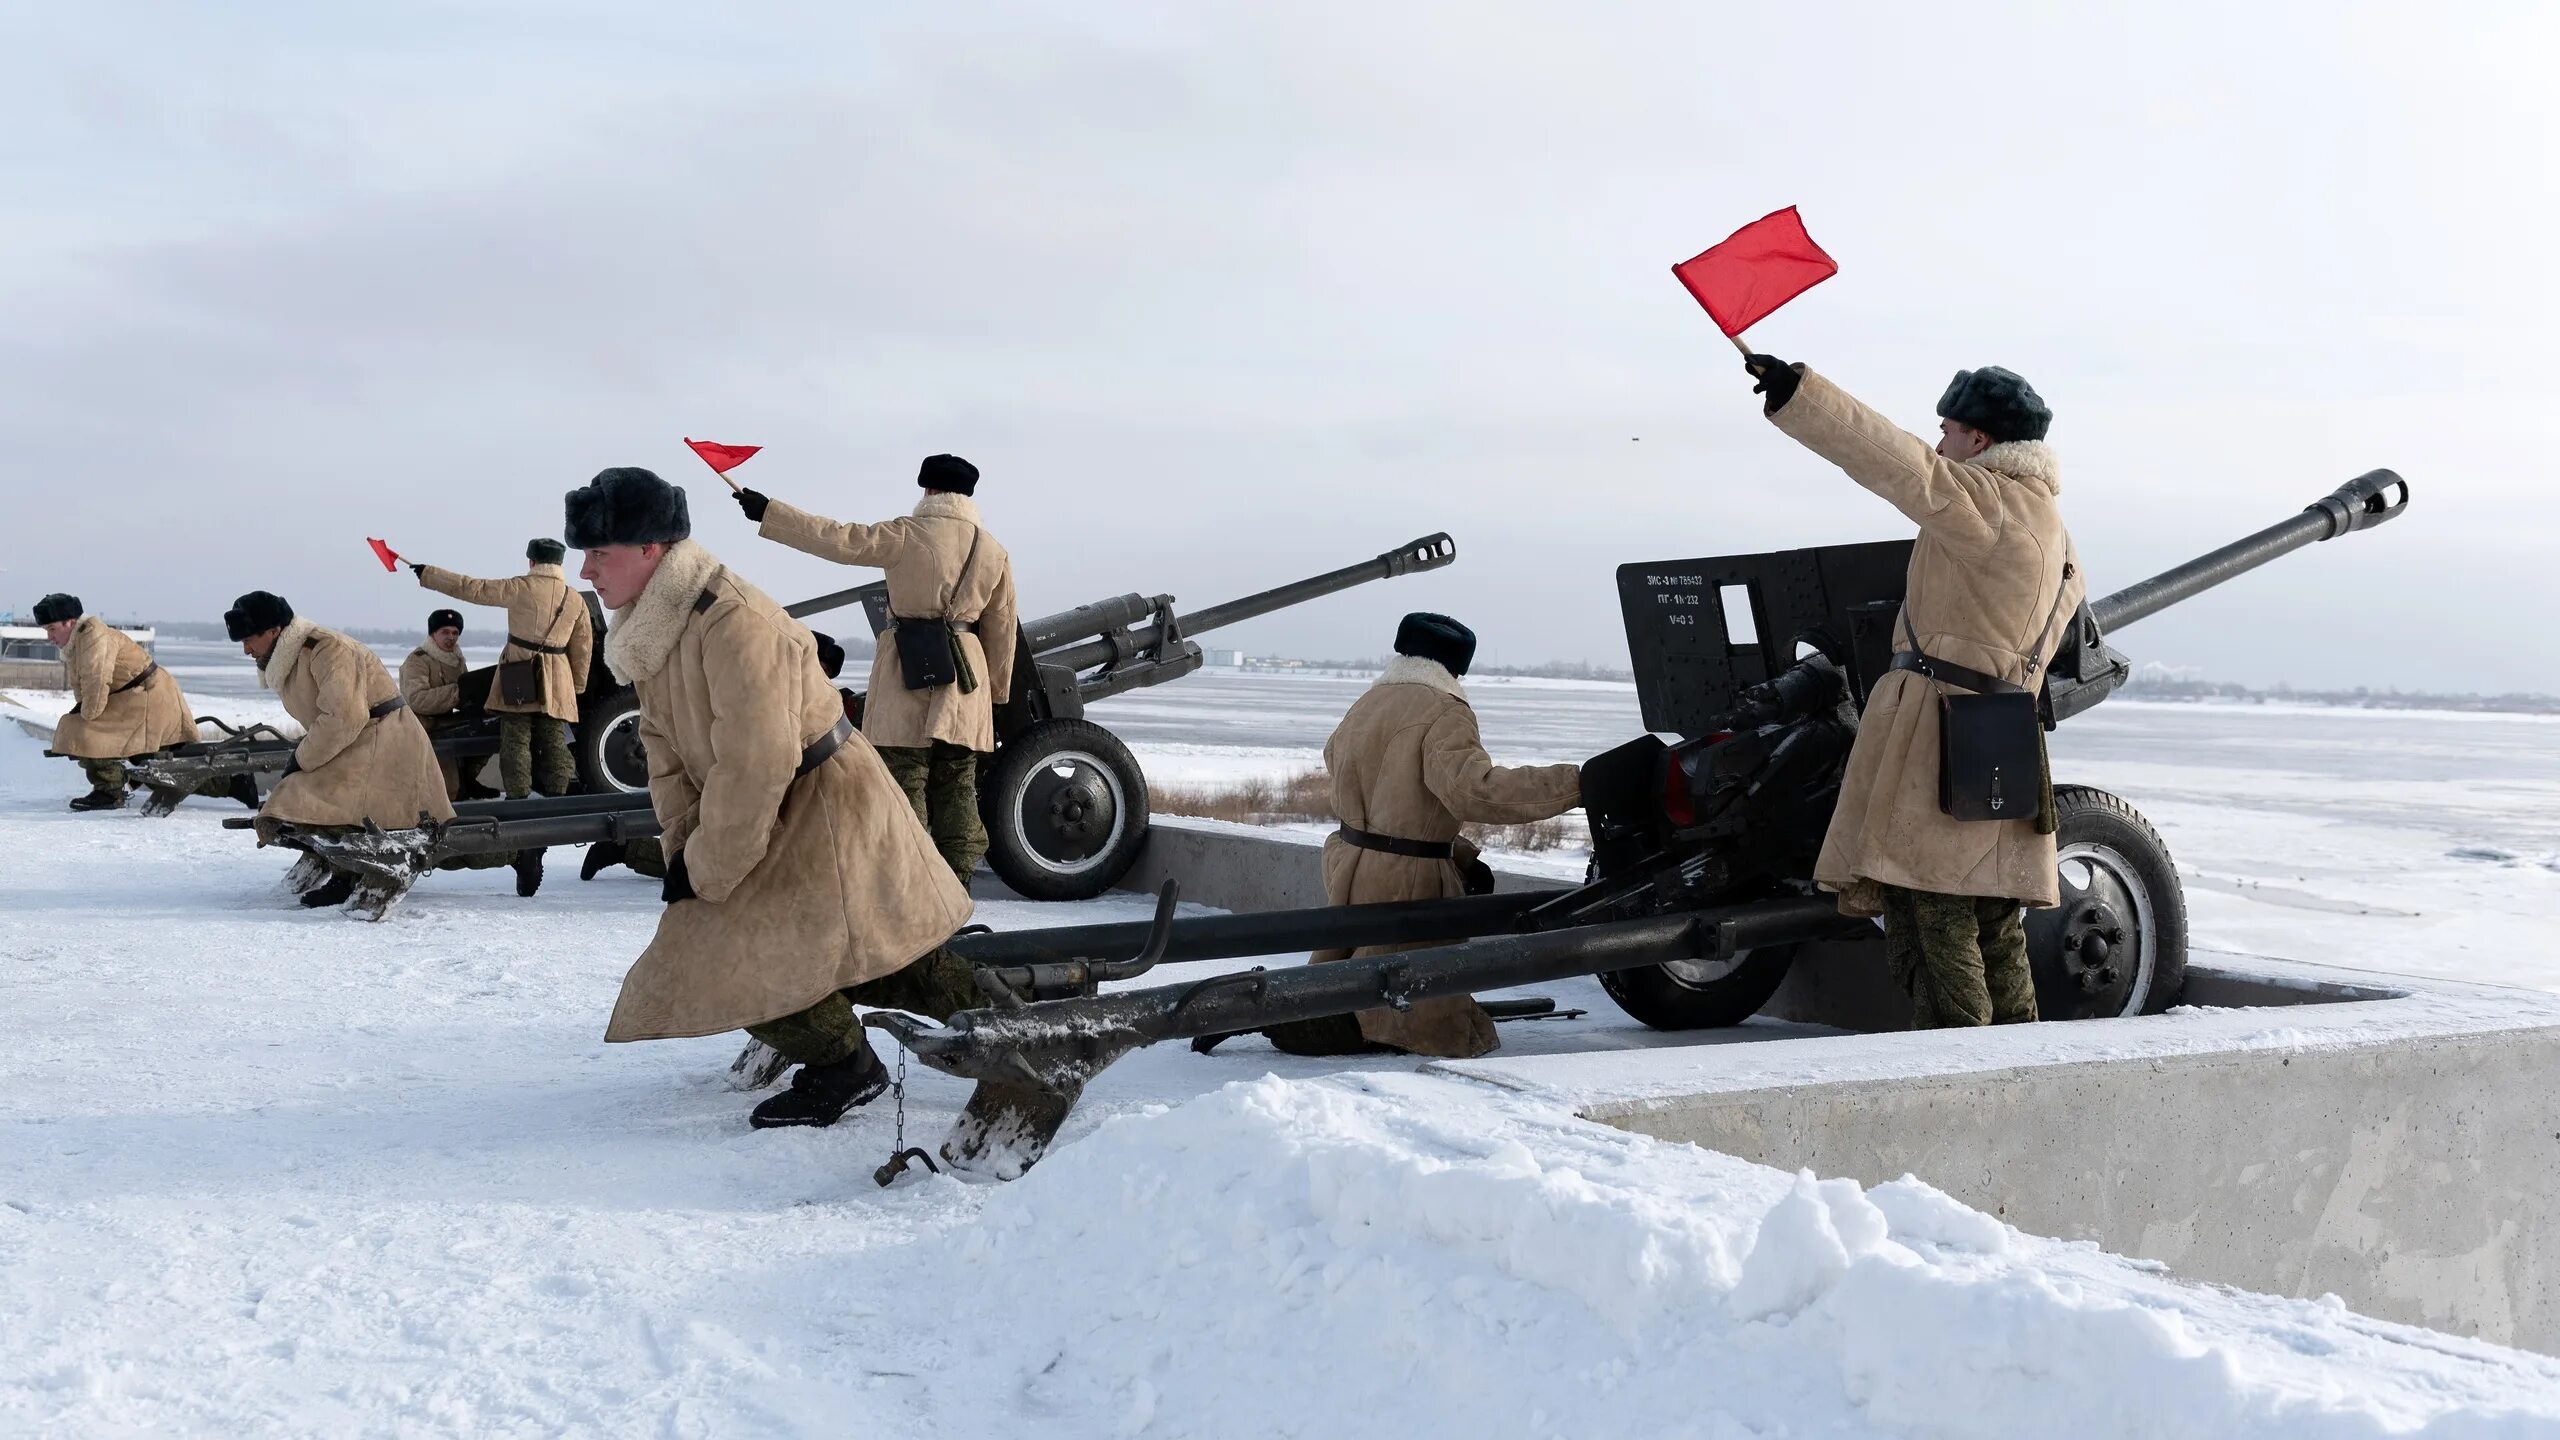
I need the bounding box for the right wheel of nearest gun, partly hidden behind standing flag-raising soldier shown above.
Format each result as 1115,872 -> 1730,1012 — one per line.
2028,784 -> 2186,1020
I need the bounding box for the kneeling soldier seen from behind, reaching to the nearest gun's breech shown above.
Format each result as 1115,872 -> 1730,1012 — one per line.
1265,612 -> 1582,1058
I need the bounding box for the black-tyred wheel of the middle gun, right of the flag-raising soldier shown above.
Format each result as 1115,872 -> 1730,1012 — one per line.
978,720 -> 1147,899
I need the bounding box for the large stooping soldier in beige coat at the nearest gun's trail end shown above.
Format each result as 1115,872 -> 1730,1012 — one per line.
563,469 -> 973,1130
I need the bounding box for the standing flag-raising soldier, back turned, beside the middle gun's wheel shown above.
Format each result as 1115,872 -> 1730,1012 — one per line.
737,456 -> 1019,884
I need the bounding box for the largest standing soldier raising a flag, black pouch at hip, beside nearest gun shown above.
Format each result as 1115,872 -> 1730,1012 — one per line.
1746,356 -> 2086,1027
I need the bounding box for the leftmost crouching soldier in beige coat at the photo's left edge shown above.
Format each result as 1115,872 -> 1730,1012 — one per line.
36,594 -> 221,810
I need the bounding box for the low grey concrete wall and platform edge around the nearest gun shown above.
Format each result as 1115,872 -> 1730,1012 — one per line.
1132,820 -> 2560,1353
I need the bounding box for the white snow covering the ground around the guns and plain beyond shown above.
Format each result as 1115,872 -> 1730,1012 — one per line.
0,664 -> 2560,1437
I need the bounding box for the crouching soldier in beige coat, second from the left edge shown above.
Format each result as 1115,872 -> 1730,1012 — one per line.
223,589 -> 519,907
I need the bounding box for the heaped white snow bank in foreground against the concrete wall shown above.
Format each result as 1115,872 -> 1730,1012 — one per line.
893,1076 -> 2560,1440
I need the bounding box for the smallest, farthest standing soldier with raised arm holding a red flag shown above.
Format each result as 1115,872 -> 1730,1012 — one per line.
410,538 -> 596,799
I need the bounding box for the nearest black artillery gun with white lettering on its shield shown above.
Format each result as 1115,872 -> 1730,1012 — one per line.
865,469 -> 2409,1176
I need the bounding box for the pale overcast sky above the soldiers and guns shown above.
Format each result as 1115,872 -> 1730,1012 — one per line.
0,0 -> 2560,692
